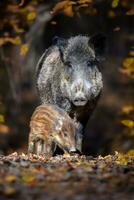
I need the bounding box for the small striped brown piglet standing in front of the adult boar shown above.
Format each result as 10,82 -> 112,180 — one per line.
28,104 -> 78,156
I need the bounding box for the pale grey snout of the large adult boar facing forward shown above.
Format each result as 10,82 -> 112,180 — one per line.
71,80 -> 91,106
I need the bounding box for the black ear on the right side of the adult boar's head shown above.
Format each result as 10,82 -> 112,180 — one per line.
89,33 -> 106,59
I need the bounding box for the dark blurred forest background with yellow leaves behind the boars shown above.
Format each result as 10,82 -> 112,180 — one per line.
0,0 -> 134,155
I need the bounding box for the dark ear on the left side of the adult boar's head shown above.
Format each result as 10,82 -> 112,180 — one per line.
52,36 -> 67,53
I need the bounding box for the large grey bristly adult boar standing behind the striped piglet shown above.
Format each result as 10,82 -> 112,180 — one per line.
37,34 -> 105,126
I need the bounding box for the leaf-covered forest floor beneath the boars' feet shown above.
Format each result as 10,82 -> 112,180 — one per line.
0,152 -> 134,200
